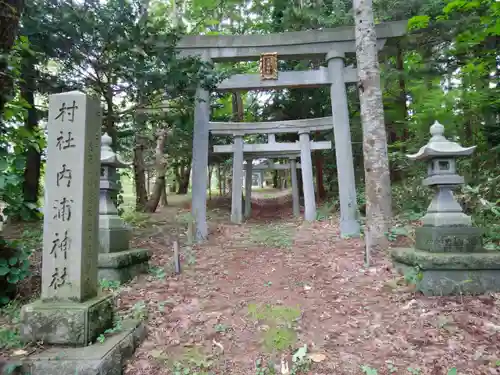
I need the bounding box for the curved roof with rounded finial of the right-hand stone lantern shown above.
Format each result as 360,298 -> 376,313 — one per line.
406,121 -> 476,160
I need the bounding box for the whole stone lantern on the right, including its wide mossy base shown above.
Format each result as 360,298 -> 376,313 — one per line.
391,121 -> 500,295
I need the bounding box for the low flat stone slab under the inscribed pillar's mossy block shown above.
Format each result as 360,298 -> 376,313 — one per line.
13,321 -> 146,375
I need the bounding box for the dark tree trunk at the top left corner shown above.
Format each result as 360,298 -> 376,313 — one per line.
0,0 -> 24,117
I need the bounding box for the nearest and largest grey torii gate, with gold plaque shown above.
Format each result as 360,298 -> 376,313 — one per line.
177,21 -> 407,240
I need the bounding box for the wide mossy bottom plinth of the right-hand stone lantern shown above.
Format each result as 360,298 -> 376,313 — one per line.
391,248 -> 500,296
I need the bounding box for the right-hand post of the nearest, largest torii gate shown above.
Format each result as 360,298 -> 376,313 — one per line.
326,51 -> 360,237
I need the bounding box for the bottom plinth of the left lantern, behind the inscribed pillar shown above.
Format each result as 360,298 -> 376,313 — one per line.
97,249 -> 151,284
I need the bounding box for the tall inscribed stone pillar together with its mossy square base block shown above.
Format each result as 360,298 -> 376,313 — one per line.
21,91 -> 113,345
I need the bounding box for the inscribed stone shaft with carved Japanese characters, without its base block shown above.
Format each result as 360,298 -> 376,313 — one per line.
41,91 -> 102,302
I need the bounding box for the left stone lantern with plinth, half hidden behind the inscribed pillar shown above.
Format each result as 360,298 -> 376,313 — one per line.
99,134 -> 149,283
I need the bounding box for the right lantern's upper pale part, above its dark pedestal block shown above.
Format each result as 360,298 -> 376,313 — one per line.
407,121 -> 476,227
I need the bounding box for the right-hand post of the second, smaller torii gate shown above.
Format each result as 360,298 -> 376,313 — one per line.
299,131 -> 316,221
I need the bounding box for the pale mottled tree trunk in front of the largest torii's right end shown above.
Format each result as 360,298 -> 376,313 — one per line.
353,0 -> 392,263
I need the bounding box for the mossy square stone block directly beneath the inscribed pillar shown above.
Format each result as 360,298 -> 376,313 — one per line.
21,295 -> 114,346
